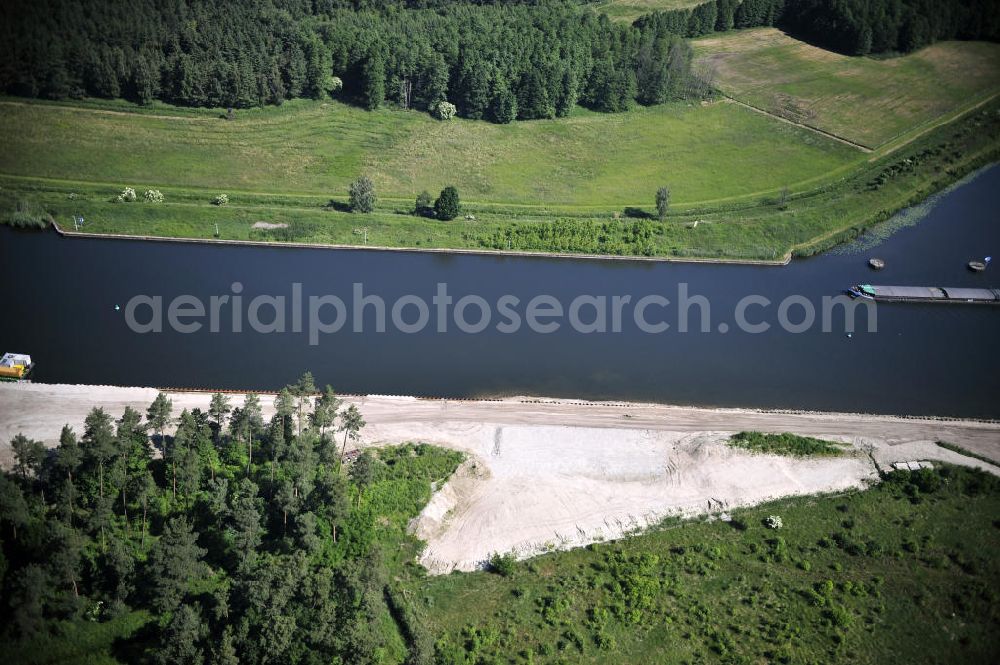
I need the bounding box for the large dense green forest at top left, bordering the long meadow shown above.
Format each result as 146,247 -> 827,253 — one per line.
0,0 -> 704,123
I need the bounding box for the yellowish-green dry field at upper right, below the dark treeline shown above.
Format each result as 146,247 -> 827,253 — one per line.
692,28 -> 1000,148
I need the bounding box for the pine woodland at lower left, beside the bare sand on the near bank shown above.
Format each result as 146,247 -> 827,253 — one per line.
0,374 -> 461,665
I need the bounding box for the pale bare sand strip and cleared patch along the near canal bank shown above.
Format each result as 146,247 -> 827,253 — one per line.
0,384 -> 1000,573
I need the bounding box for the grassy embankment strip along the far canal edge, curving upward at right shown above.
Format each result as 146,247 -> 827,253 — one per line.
0,94 -> 1000,261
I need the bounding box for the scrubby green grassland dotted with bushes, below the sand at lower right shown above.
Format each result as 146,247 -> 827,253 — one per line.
420,467 -> 1000,665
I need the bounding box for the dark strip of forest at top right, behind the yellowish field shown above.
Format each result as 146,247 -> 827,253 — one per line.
636,0 -> 1000,55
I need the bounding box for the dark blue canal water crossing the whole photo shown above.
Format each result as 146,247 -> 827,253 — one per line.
0,166 -> 1000,418
